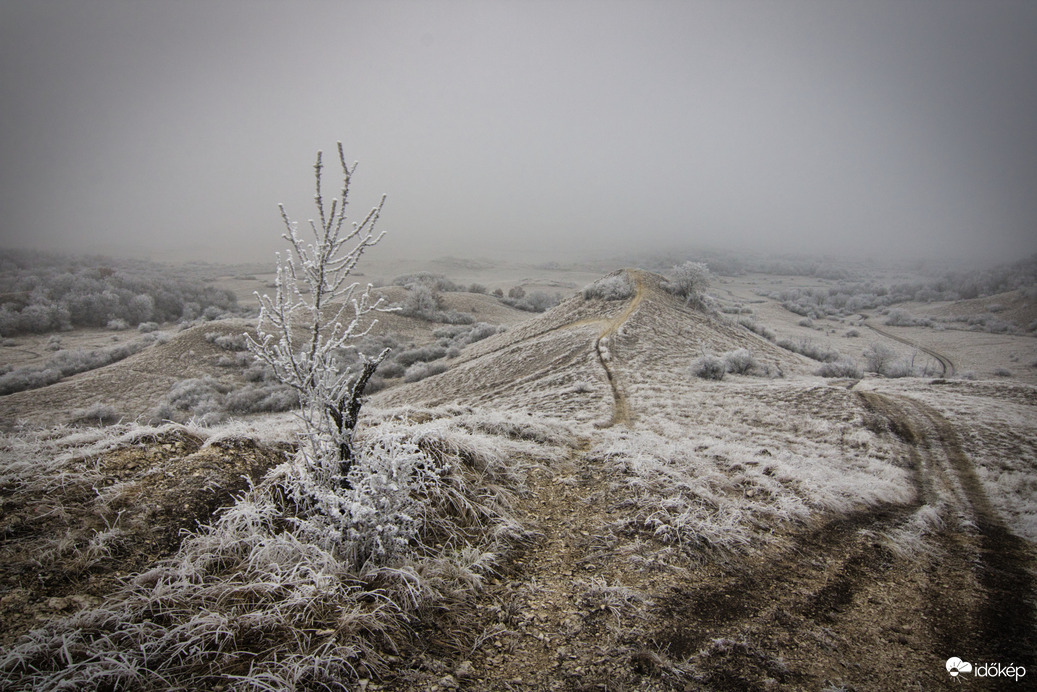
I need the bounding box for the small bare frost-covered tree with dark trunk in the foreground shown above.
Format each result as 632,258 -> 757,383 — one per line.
248,142 -> 391,488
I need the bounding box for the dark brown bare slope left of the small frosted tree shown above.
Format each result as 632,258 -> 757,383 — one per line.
0,433 -> 285,644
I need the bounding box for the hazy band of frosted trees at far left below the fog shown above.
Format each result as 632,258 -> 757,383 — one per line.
0,250 -> 237,336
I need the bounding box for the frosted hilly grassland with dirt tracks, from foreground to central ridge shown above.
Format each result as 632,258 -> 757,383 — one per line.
0,261 -> 1037,690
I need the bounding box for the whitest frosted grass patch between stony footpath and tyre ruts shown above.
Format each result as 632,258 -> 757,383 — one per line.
590,408 -> 914,557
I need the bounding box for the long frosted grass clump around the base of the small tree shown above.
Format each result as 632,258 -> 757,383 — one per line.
0,410 -> 563,690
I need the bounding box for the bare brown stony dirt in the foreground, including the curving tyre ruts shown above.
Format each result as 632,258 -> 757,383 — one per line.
414,388 -> 1037,691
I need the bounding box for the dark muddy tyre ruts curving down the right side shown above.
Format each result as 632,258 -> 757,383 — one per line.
653,392 -> 1037,690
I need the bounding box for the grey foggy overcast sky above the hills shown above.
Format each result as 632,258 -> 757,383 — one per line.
0,0 -> 1037,261
